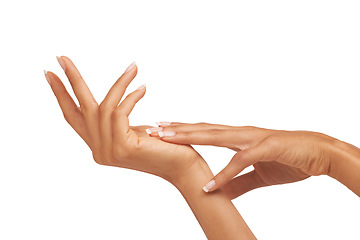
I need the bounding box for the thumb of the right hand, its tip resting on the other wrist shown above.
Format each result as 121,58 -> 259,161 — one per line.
203,144 -> 266,192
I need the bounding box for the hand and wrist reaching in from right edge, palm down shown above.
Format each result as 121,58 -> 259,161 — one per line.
150,122 -> 360,199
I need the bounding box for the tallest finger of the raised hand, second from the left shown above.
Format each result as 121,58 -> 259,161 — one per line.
57,56 -> 97,112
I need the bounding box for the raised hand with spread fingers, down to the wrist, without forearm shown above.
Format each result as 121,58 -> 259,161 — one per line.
45,56 -> 207,183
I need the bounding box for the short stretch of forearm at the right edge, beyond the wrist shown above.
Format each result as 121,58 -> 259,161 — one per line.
329,141 -> 360,197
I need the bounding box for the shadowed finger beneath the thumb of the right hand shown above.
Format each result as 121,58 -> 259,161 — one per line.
222,170 -> 267,199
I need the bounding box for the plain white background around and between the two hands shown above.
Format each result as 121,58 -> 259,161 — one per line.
0,0 -> 360,240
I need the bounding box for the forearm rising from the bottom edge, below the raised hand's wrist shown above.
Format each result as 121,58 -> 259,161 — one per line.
174,159 -> 256,240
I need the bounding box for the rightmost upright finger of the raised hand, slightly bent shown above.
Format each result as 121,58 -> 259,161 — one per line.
113,85 -> 146,140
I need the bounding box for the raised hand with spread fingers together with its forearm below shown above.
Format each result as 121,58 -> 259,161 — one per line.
45,56 -> 255,239
